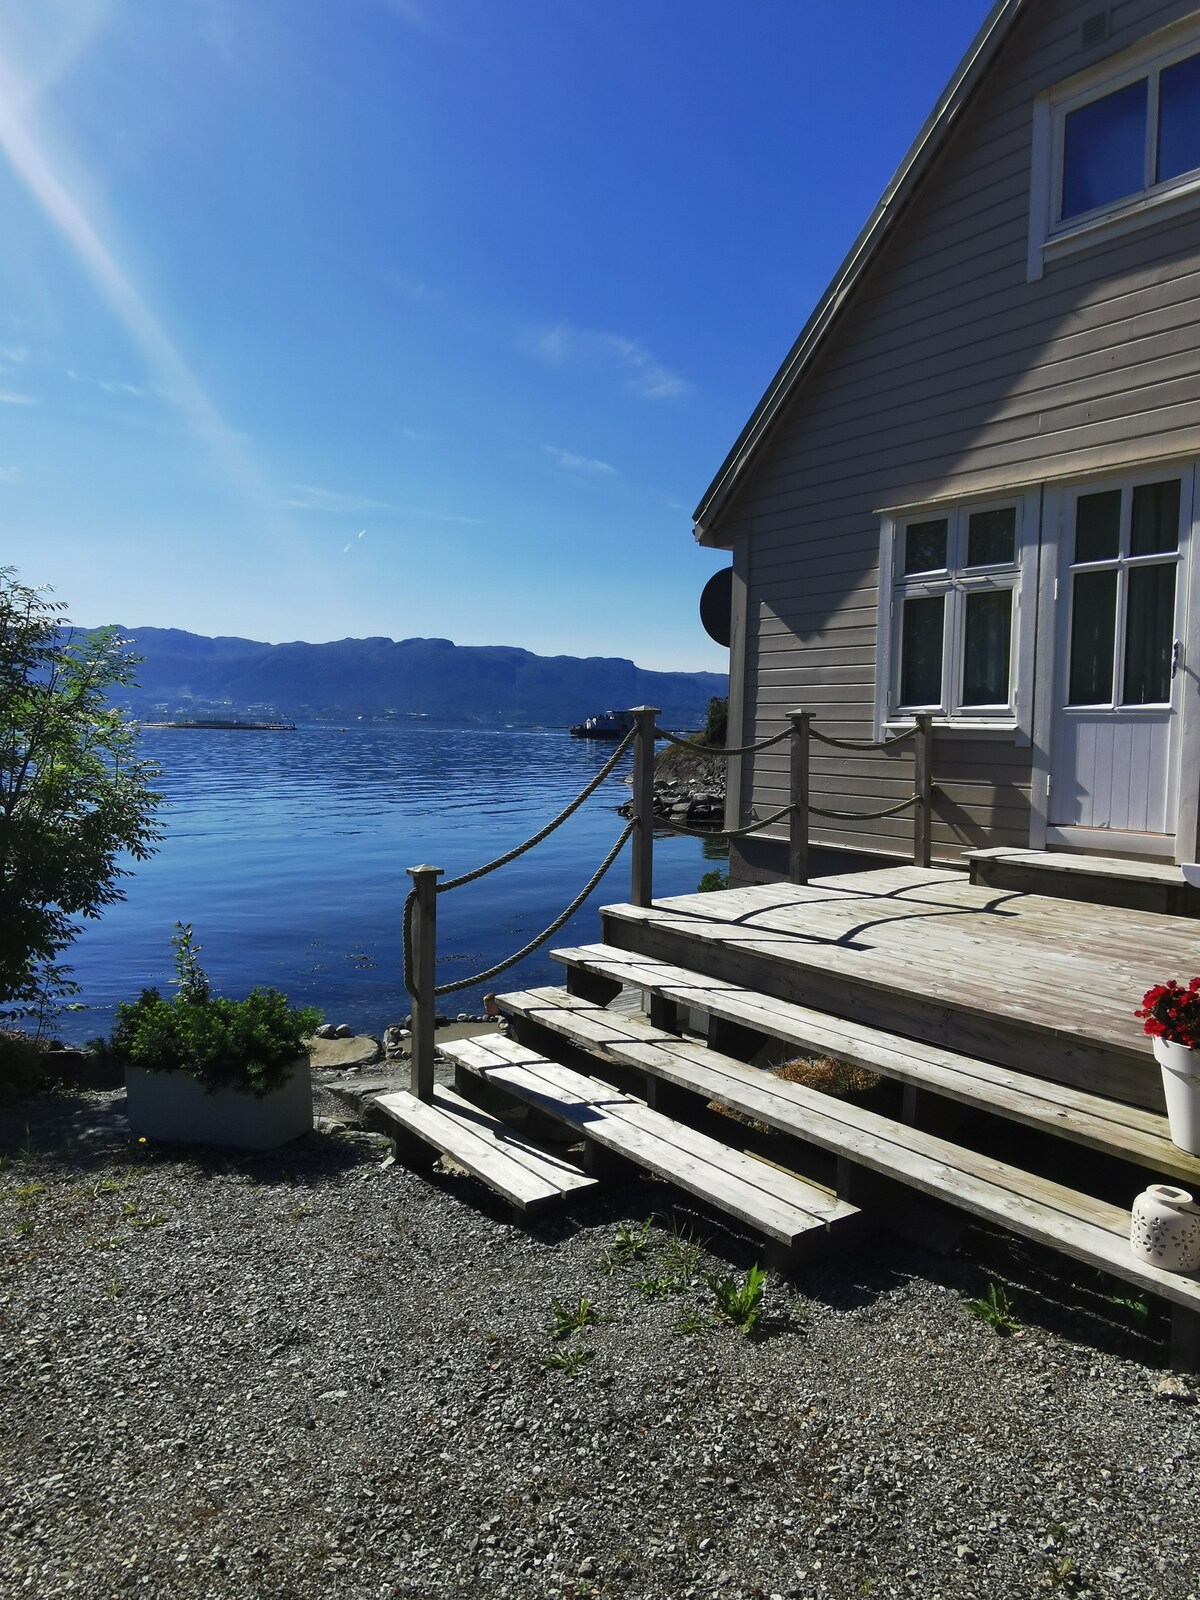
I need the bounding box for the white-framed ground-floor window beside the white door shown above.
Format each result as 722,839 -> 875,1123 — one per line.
880,496 -> 1027,726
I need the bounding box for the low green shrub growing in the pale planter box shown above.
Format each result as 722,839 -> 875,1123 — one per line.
91,923 -> 322,1098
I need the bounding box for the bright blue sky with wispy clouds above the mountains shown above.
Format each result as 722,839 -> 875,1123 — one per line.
0,0 -> 987,670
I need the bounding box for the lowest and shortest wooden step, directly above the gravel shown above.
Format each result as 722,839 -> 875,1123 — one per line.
374,1083 -> 597,1211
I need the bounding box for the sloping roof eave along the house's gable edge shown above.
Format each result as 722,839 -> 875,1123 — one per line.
693,0 -> 1030,547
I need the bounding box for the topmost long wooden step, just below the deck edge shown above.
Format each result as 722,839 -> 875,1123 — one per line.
552,944 -> 1200,1189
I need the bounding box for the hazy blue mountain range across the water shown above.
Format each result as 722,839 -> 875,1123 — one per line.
103,627 -> 726,726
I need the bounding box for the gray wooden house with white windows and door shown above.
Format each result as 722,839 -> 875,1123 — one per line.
694,0 -> 1200,882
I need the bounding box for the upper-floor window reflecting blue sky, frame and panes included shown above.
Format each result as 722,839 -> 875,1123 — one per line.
1029,21 -> 1200,278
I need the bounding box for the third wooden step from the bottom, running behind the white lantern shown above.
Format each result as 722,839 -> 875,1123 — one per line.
498,989 -> 1200,1314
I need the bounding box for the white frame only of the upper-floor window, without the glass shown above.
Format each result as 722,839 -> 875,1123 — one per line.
1027,14 -> 1200,282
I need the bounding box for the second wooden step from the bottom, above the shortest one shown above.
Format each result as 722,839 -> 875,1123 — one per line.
442,1034 -> 858,1248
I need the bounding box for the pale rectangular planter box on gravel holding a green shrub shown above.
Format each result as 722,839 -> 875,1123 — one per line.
125,1056 -> 312,1150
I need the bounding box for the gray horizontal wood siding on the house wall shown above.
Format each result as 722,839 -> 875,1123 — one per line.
714,0 -> 1200,859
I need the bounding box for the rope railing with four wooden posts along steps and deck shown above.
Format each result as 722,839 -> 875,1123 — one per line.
403,706 -> 933,1101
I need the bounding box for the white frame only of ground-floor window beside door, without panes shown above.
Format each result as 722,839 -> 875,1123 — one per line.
875,490 -> 1038,742
